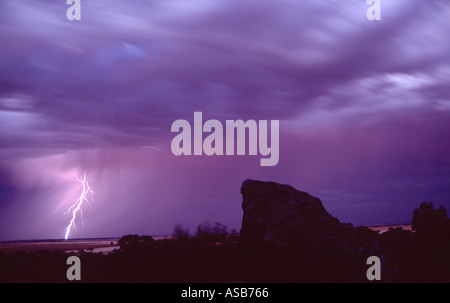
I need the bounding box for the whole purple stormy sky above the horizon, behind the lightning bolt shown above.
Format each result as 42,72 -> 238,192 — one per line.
0,0 -> 450,240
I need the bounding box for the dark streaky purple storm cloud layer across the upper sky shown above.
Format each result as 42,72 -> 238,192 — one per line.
0,1 -> 449,159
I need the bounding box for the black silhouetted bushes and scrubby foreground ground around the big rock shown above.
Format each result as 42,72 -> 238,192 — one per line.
0,202 -> 450,283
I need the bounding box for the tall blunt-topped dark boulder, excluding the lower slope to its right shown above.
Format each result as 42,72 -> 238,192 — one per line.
241,180 -> 340,246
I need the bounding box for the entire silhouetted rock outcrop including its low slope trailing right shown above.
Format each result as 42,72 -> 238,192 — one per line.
241,180 -> 389,281
